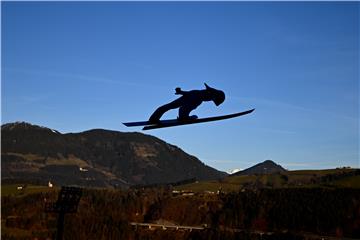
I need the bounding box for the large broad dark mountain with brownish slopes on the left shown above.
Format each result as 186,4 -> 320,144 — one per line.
1,122 -> 226,187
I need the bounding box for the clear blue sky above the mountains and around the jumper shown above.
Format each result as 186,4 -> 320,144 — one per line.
1,2 -> 360,171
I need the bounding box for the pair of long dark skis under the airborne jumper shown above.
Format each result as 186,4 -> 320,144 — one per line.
123,109 -> 255,130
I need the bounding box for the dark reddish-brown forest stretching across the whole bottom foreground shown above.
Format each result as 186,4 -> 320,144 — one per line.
1,188 -> 360,240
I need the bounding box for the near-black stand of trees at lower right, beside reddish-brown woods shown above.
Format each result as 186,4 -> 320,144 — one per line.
217,188 -> 360,238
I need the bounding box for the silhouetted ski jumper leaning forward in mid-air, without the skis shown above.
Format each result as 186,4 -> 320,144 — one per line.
149,83 -> 225,123
